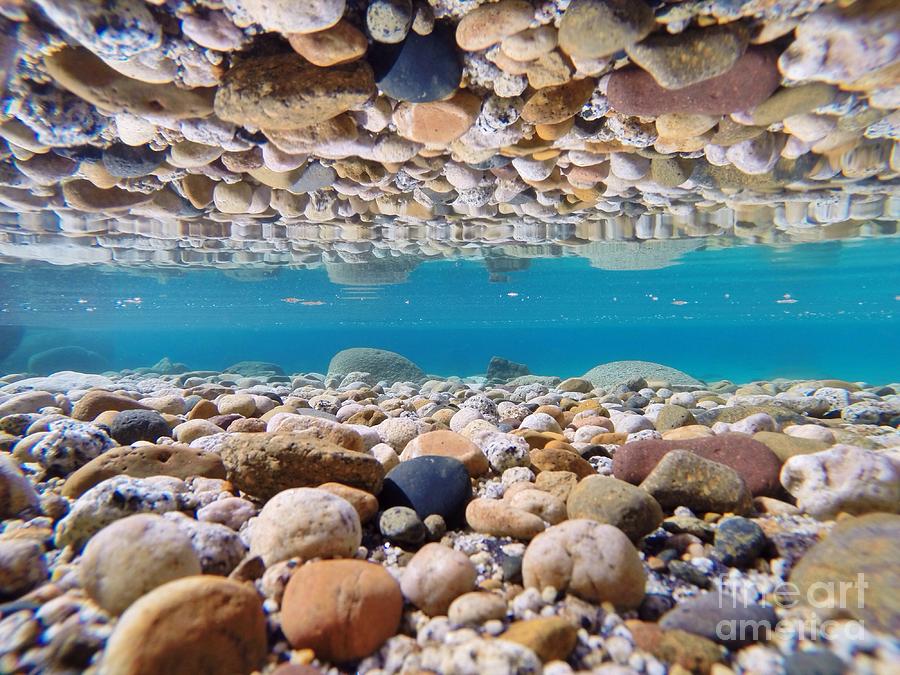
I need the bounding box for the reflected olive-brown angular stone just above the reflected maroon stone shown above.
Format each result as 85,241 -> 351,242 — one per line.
626,24 -> 750,89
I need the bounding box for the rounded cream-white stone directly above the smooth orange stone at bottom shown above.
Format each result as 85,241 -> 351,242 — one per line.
247,488 -> 362,567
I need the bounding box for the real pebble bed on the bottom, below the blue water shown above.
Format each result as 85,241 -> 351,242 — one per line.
0,352 -> 900,675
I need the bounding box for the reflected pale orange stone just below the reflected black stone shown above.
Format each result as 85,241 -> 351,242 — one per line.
393,91 -> 481,146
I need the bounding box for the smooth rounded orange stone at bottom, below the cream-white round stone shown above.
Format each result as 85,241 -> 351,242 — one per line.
281,560 -> 403,663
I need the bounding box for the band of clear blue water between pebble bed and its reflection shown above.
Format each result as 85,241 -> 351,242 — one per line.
0,238 -> 900,383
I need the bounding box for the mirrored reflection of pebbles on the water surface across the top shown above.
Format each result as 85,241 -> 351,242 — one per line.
0,0 -> 900,266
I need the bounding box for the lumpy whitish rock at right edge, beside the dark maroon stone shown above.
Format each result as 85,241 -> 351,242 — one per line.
781,445 -> 900,520
